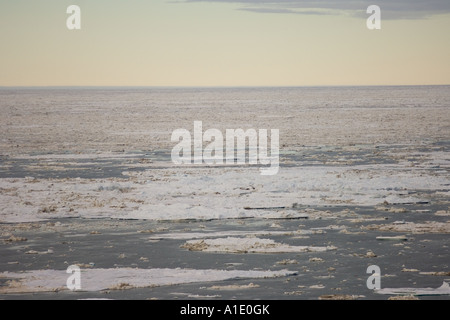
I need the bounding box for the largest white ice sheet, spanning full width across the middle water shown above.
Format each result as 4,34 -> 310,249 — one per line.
0,165 -> 449,222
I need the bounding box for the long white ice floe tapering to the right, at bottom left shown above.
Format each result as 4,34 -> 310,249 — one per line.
0,268 -> 296,293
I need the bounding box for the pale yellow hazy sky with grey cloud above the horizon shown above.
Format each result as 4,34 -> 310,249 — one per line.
0,0 -> 450,87
